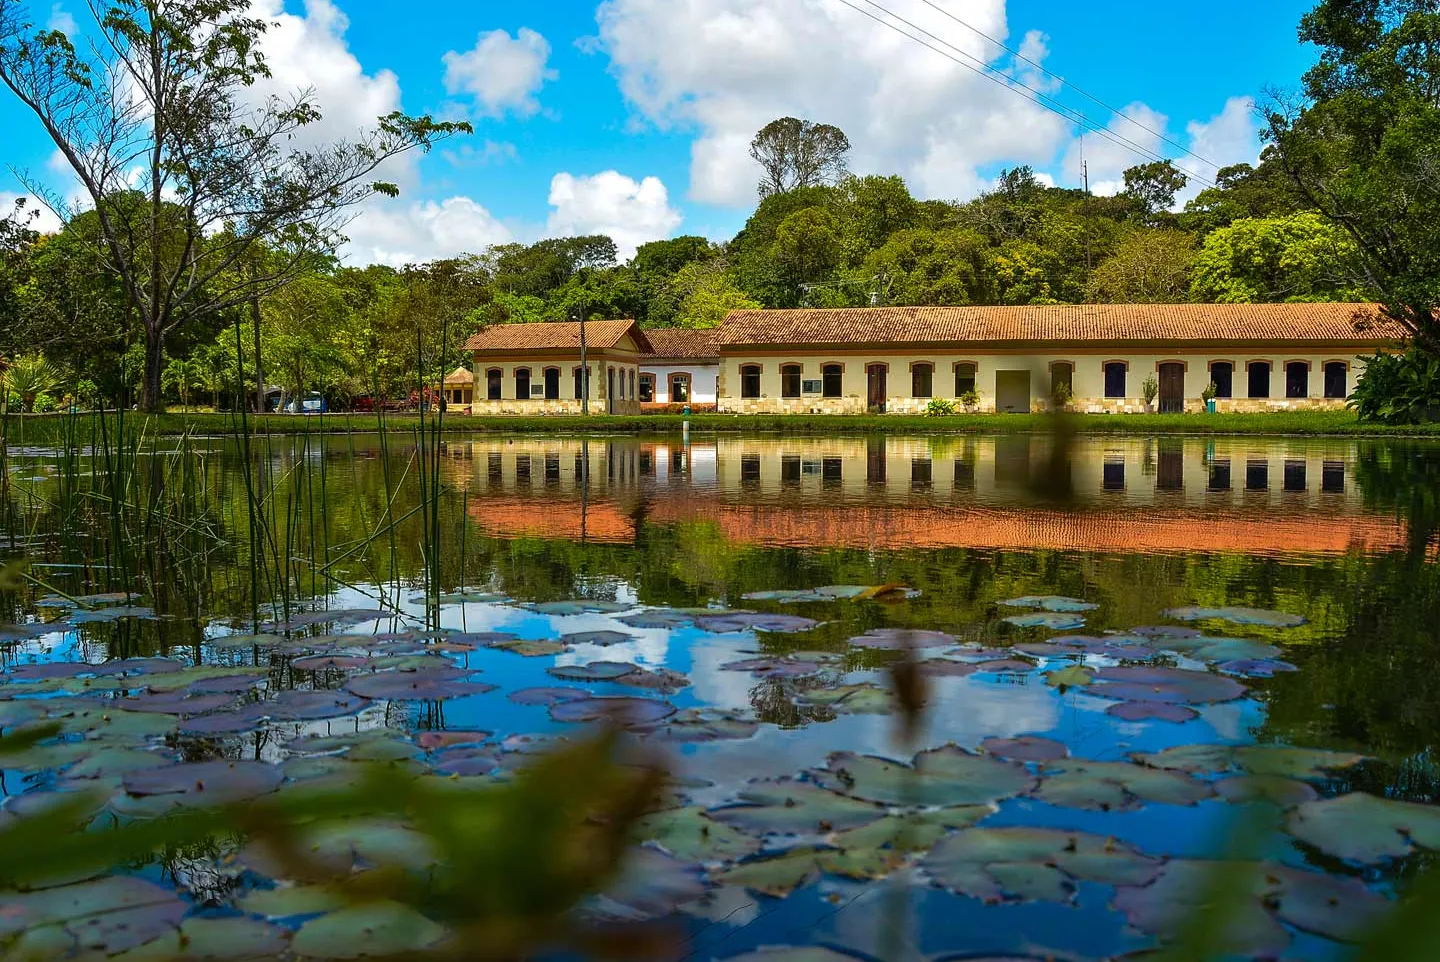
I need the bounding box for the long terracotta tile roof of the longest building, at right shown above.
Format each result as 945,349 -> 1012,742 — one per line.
717,304 -> 1405,347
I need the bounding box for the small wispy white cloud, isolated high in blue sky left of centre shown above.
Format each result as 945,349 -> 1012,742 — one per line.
444,27 -> 559,117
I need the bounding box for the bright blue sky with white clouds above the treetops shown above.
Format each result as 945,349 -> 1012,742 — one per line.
0,0 -> 1313,264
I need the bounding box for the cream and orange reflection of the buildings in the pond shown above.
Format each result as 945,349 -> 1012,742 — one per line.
448,435 -> 1405,554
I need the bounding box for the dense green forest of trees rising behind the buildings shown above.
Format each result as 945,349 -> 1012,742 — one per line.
0,0 -> 1440,418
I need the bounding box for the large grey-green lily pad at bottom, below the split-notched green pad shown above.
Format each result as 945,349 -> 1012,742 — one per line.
922,828 -> 1161,902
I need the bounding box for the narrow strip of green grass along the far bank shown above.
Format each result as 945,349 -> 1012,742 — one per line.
4,410 -> 1440,445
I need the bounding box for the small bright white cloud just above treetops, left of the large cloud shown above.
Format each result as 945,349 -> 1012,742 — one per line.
547,170 -> 683,261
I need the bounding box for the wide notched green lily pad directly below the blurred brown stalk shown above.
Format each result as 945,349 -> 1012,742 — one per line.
815,745 -> 1035,805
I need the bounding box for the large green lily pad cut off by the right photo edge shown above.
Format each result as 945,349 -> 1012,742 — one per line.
1286,792 -> 1440,864
